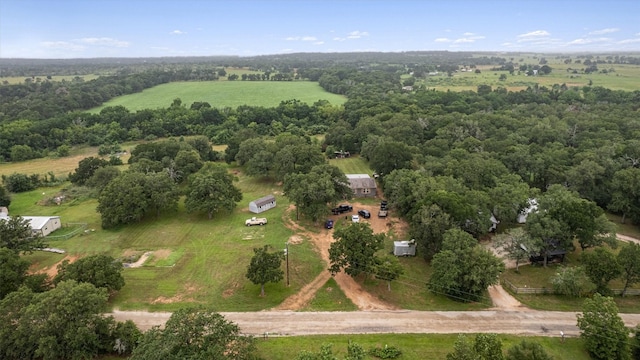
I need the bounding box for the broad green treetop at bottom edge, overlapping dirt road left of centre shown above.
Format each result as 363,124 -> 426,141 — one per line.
130,307 -> 256,360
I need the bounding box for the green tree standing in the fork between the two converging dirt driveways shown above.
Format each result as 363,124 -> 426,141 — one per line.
329,222 -> 385,277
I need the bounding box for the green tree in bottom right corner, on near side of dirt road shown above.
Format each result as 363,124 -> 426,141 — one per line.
577,293 -> 631,360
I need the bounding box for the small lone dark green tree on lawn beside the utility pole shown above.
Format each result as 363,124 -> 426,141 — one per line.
247,245 -> 284,296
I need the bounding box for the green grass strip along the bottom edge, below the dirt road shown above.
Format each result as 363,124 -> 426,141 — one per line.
257,334 -> 589,360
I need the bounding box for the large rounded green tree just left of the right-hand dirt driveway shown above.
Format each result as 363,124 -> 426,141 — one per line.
427,229 -> 504,301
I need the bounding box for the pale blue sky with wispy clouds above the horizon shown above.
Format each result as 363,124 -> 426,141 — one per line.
0,0 -> 640,58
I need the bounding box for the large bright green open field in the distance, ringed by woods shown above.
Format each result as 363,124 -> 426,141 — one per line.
90,81 -> 347,113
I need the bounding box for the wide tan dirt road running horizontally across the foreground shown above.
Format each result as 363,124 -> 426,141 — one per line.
112,310 -> 640,336
